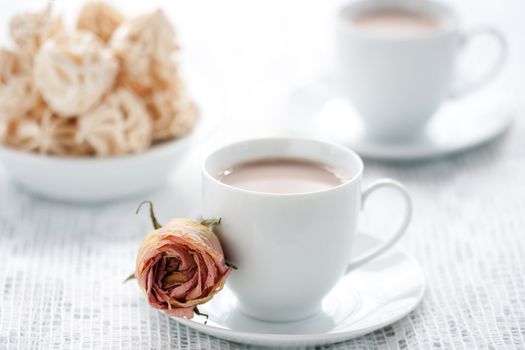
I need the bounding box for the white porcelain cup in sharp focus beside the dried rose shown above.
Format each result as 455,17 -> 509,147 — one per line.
202,138 -> 412,321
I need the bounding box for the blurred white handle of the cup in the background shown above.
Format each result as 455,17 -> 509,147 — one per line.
449,27 -> 509,99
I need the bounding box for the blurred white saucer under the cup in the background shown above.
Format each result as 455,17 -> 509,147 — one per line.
284,76 -> 515,160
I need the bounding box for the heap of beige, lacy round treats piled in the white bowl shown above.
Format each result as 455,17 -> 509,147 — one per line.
0,2 -> 197,157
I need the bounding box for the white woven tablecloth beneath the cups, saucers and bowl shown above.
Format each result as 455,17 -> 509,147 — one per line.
0,0 -> 525,349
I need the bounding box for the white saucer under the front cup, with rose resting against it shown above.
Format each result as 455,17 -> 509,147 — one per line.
175,235 -> 425,347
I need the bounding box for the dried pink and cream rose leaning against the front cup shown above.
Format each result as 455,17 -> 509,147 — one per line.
135,203 -> 231,318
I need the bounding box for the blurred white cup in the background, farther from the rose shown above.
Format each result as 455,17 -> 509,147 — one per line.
336,0 -> 507,140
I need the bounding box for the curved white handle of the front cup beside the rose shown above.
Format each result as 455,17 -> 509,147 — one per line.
346,179 -> 412,273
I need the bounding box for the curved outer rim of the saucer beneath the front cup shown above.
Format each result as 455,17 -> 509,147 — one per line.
171,233 -> 428,346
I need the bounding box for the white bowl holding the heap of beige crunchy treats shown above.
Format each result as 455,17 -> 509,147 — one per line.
0,134 -> 194,202
